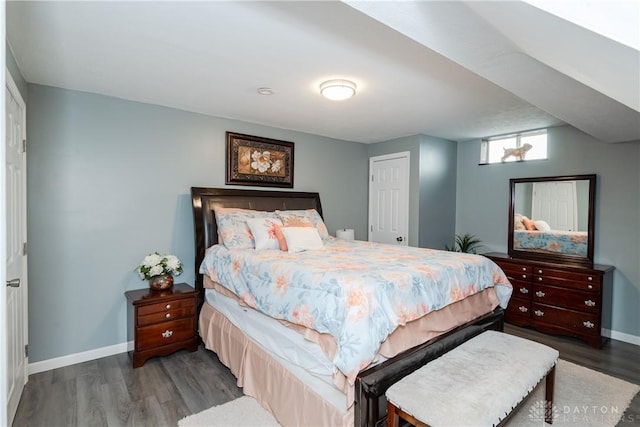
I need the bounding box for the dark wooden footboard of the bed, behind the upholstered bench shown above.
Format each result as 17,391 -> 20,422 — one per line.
354,307 -> 504,427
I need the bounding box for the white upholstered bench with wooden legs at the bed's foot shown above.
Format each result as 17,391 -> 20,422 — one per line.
386,331 -> 558,427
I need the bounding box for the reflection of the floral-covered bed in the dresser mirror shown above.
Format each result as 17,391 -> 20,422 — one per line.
513,230 -> 588,257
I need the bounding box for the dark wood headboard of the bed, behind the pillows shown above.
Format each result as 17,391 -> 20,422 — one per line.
191,187 -> 322,302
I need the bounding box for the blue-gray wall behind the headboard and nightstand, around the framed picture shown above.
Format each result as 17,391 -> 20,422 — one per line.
27,84 -> 368,363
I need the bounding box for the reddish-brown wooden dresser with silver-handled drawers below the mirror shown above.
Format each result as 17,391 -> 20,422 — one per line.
484,252 -> 614,348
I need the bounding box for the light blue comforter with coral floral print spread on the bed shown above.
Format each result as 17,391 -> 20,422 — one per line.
200,238 -> 512,385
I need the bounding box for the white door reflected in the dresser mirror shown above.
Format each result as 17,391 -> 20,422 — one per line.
531,181 -> 578,231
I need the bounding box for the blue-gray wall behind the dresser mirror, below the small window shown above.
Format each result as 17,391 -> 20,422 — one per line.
456,126 -> 640,337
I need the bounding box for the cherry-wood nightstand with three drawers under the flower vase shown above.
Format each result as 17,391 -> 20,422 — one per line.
125,283 -> 198,368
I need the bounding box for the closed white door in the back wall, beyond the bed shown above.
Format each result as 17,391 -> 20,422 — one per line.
369,151 -> 409,246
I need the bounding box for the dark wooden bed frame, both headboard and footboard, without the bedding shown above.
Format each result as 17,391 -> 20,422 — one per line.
191,187 -> 504,426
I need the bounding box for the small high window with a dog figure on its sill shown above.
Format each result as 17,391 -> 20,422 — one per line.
480,129 -> 547,165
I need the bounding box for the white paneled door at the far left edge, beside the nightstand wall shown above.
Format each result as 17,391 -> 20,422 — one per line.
5,68 -> 27,425
